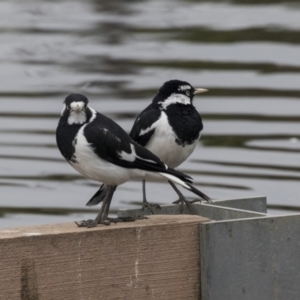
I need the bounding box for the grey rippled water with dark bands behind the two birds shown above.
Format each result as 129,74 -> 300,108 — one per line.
0,0 -> 300,227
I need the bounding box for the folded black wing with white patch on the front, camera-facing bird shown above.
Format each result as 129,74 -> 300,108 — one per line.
84,113 -> 192,182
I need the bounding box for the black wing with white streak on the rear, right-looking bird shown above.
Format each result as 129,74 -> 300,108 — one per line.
129,103 -> 161,147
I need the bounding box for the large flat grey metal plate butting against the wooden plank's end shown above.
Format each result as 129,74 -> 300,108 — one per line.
199,214 -> 300,300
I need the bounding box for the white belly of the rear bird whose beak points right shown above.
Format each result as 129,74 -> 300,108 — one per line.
145,111 -> 200,168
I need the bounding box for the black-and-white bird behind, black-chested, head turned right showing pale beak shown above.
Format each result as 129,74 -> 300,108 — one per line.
87,80 -> 212,213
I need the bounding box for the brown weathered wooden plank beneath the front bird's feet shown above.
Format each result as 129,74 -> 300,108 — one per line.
0,215 -> 208,300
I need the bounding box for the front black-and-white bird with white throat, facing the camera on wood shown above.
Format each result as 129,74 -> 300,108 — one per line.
56,94 -> 211,227
